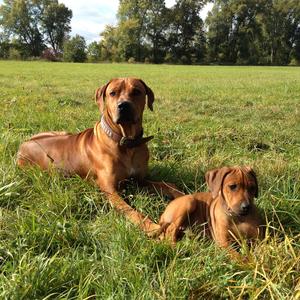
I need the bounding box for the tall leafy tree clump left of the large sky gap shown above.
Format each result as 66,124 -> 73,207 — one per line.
0,0 -> 72,56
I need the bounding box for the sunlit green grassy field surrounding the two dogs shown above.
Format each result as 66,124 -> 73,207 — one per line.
0,61 -> 300,300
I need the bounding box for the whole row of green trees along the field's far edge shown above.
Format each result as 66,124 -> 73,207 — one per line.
0,0 -> 300,65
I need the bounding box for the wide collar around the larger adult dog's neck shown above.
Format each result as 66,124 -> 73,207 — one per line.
100,115 -> 154,148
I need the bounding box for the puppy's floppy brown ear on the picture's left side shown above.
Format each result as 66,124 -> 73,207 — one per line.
205,167 -> 231,198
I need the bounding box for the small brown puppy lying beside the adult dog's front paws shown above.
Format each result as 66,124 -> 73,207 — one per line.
159,167 -> 261,255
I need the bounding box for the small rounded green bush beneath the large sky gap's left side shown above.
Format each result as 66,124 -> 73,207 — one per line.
63,34 -> 87,62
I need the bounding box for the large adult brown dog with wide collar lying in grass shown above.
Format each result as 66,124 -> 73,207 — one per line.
17,78 -> 182,235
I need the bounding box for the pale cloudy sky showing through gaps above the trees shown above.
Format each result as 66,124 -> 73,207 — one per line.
0,0 -> 211,43
